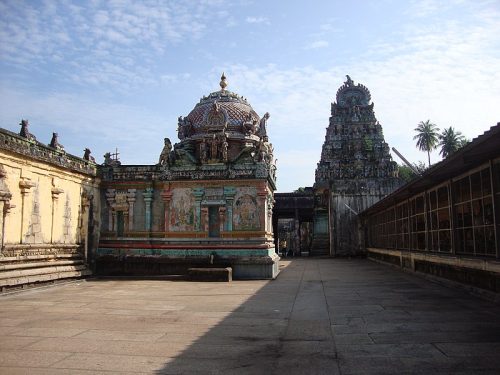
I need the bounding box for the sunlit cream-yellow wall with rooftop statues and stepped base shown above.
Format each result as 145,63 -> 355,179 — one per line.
0,120 -> 99,288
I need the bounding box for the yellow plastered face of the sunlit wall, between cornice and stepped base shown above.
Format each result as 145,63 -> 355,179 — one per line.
0,150 -> 99,245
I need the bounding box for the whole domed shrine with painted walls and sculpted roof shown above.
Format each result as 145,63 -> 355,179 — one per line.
96,74 -> 279,279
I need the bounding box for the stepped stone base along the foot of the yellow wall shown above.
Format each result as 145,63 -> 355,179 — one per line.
0,253 -> 91,292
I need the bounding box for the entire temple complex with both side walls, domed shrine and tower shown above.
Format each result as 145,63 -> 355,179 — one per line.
0,75 -> 500,293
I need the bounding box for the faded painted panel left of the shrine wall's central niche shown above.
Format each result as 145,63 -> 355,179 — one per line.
170,188 -> 195,232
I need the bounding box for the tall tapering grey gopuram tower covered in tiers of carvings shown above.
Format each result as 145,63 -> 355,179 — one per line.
312,76 -> 401,256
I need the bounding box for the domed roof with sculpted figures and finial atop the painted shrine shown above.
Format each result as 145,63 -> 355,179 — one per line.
158,74 -> 276,185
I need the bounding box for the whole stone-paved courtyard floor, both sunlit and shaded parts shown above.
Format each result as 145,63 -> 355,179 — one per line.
0,259 -> 500,375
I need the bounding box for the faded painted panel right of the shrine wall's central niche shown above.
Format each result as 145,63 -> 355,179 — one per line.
233,187 -> 260,230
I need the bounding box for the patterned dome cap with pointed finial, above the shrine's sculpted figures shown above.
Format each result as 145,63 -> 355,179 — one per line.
179,73 -> 260,135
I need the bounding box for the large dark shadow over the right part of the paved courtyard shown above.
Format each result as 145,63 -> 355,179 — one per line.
157,259 -> 500,374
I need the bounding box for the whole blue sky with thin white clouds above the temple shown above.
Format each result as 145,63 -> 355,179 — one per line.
0,0 -> 500,192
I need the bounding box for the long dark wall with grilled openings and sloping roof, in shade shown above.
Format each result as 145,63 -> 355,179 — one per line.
360,123 -> 500,293
